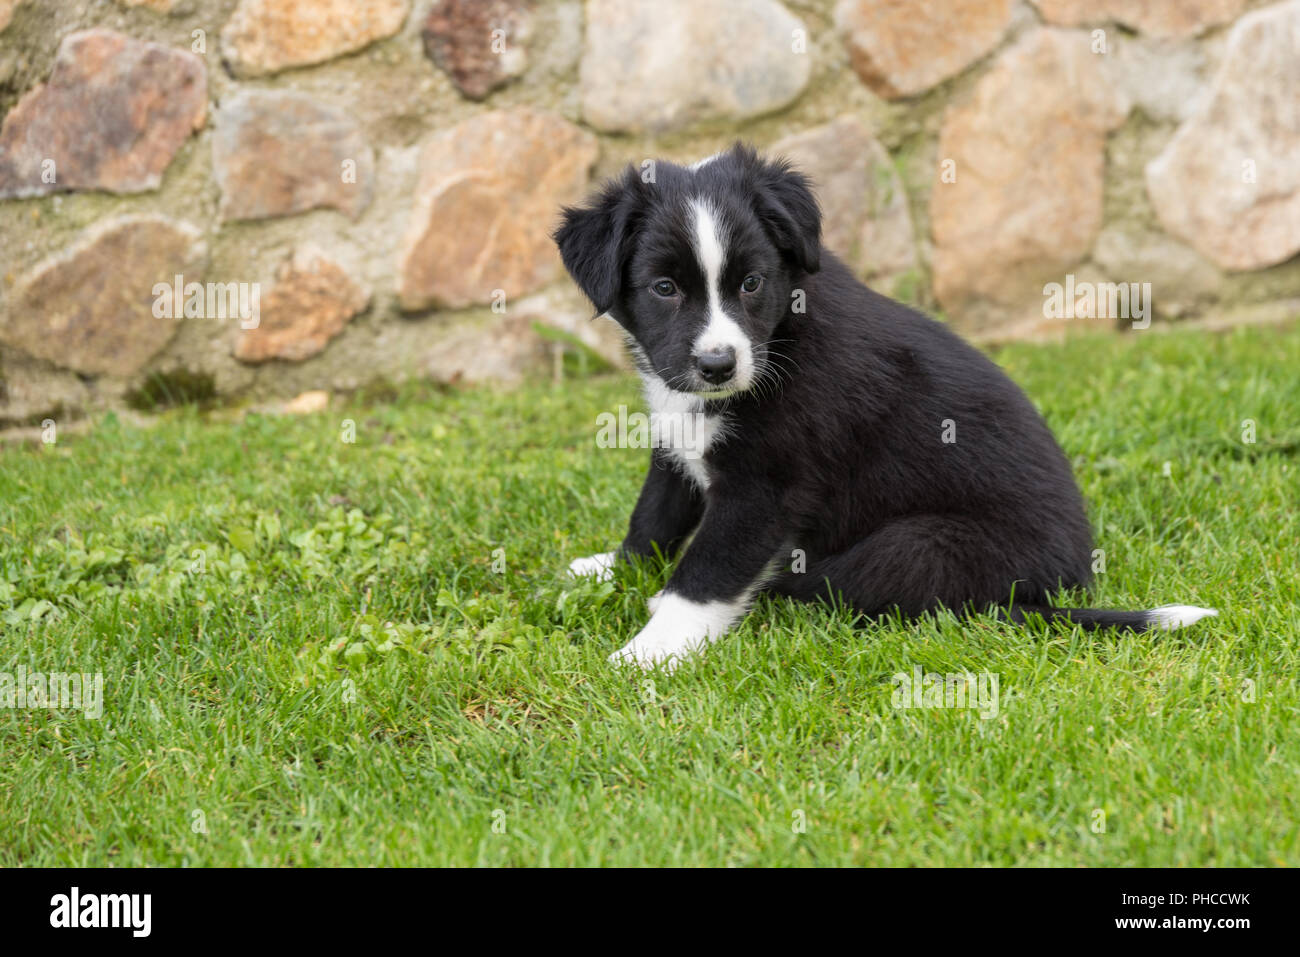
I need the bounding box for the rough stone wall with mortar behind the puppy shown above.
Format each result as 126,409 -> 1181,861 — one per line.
0,0 -> 1300,424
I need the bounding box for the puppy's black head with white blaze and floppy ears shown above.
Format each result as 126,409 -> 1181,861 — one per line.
555,144 -> 822,399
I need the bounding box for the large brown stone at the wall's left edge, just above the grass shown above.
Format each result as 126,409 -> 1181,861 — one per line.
0,216 -> 204,376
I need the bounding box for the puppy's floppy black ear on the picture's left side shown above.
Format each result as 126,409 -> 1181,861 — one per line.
554,166 -> 645,315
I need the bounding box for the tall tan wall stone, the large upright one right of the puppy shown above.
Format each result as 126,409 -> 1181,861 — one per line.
930,29 -> 1128,322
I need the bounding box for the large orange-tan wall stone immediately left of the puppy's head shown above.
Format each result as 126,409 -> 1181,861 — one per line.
398,109 -> 598,309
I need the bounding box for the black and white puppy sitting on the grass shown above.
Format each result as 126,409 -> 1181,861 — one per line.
555,146 -> 1217,666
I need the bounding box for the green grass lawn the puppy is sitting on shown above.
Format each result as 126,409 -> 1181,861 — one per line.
0,323 -> 1300,866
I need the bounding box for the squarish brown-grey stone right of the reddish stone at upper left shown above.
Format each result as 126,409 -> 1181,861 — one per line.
212,90 -> 374,220
